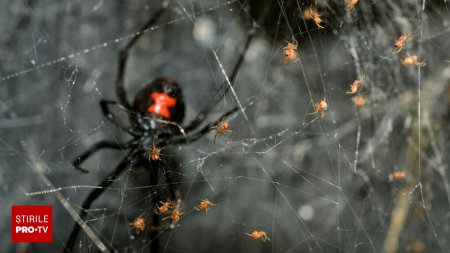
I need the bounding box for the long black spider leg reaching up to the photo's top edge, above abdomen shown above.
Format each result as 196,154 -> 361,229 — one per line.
116,1 -> 168,109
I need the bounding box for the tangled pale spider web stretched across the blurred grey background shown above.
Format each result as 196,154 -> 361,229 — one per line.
0,0 -> 450,252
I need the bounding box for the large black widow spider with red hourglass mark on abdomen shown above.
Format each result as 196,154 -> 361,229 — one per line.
65,1 -> 255,252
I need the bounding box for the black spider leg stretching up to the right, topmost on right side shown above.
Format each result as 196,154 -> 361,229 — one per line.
181,28 -> 256,131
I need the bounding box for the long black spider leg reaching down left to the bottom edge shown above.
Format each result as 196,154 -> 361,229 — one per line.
64,157 -> 130,253
